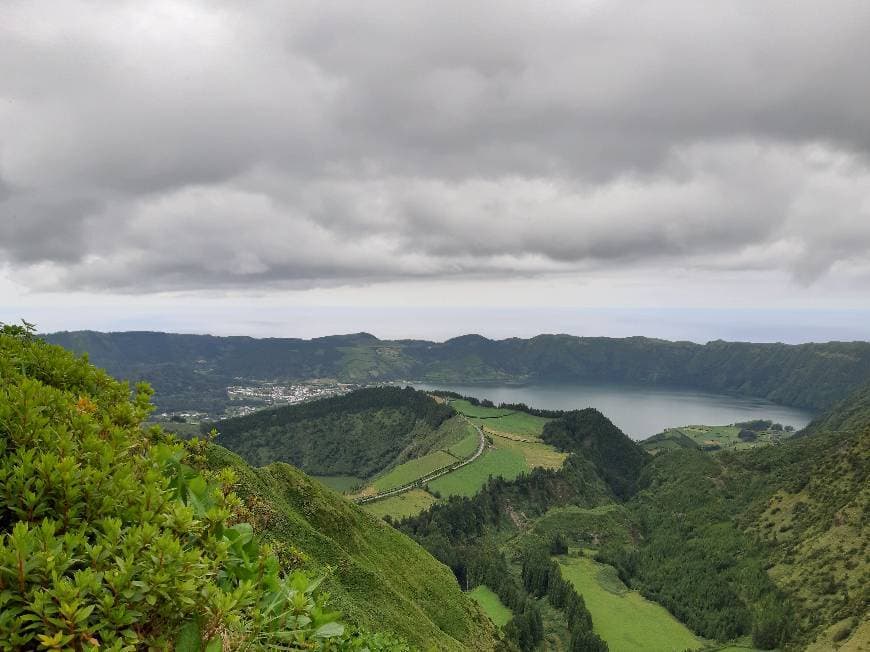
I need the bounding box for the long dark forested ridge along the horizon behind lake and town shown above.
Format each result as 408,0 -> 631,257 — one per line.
44,331 -> 870,412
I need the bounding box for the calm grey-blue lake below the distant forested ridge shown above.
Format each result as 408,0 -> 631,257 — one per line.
414,383 -> 814,439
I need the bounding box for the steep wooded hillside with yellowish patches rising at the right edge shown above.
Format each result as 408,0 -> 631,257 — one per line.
602,390 -> 870,649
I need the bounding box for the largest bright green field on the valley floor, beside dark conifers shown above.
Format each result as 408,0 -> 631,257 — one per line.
559,557 -> 704,652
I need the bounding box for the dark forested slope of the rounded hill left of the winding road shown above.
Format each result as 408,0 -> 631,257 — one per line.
210,387 -> 454,478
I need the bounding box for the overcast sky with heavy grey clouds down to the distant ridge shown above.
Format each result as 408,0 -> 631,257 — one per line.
0,0 -> 870,342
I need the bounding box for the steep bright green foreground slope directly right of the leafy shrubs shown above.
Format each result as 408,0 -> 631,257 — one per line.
208,446 -> 496,650
